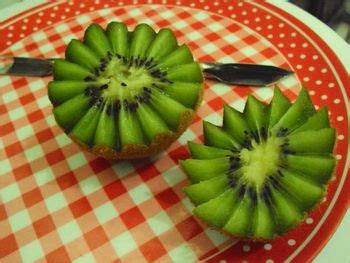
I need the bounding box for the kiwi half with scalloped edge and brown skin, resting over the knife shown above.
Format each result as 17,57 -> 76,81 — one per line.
48,22 -> 203,159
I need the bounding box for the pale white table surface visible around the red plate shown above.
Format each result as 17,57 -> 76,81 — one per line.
0,0 -> 350,263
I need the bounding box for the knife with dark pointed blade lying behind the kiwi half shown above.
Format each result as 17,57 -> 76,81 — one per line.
0,56 -> 294,86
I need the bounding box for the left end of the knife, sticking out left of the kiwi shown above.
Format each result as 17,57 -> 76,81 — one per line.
0,56 -> 52,76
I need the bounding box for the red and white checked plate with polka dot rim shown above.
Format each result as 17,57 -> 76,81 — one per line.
0,0 -> 350,262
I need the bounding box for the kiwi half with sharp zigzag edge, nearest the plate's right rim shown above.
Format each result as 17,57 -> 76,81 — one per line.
180,86 -> 335,240
